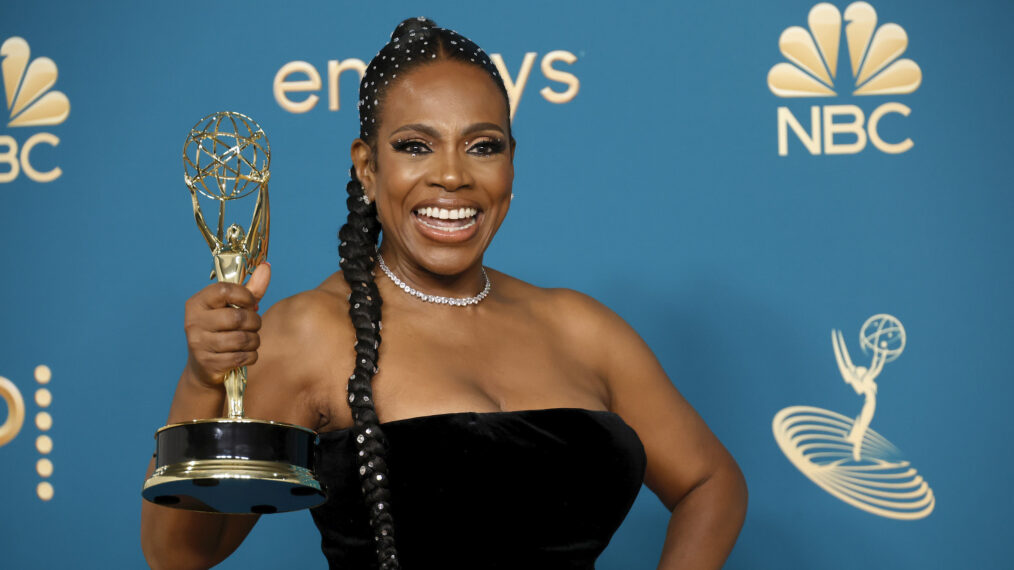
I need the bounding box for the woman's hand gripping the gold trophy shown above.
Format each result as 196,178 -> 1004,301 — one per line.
184,262 -> 271,387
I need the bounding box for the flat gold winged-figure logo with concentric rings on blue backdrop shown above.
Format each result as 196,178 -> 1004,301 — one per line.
772,314 -> 936,520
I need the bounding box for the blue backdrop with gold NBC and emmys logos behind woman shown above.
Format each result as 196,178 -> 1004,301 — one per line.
0,0 -> 1014,570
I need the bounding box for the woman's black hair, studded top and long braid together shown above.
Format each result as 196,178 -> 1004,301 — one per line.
338,18 -> 510,570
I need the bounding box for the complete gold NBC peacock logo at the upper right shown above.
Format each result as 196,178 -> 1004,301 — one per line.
768,2 -> 923,156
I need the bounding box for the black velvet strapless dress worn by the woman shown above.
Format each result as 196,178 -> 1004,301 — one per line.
311,408 -> 647,570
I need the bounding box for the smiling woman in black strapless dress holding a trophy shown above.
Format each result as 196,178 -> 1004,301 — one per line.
142,18 -> 746,569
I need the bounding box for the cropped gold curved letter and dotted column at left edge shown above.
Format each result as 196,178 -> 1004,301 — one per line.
0,364 -> 53,501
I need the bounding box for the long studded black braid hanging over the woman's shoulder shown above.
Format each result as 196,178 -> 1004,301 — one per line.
338,167 -> 401,570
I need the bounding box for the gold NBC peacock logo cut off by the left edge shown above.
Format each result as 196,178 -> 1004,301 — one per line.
0,37 -> 70,183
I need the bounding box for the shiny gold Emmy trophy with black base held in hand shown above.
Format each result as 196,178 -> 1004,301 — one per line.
141,112 -> 324,513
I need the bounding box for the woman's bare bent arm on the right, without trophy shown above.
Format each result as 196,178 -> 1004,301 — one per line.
569,293 -> 746,569
